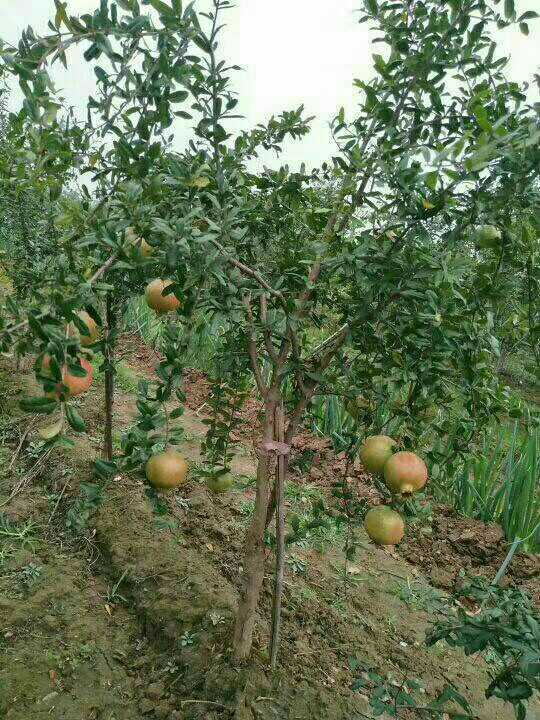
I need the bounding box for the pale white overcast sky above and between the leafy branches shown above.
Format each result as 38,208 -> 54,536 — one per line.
0,0 -> 540,166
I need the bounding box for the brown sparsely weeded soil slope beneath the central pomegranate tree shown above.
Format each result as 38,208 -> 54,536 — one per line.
0,356 -> 533,720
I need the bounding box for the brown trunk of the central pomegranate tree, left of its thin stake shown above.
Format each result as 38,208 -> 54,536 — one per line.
234,400 -> 276,661
